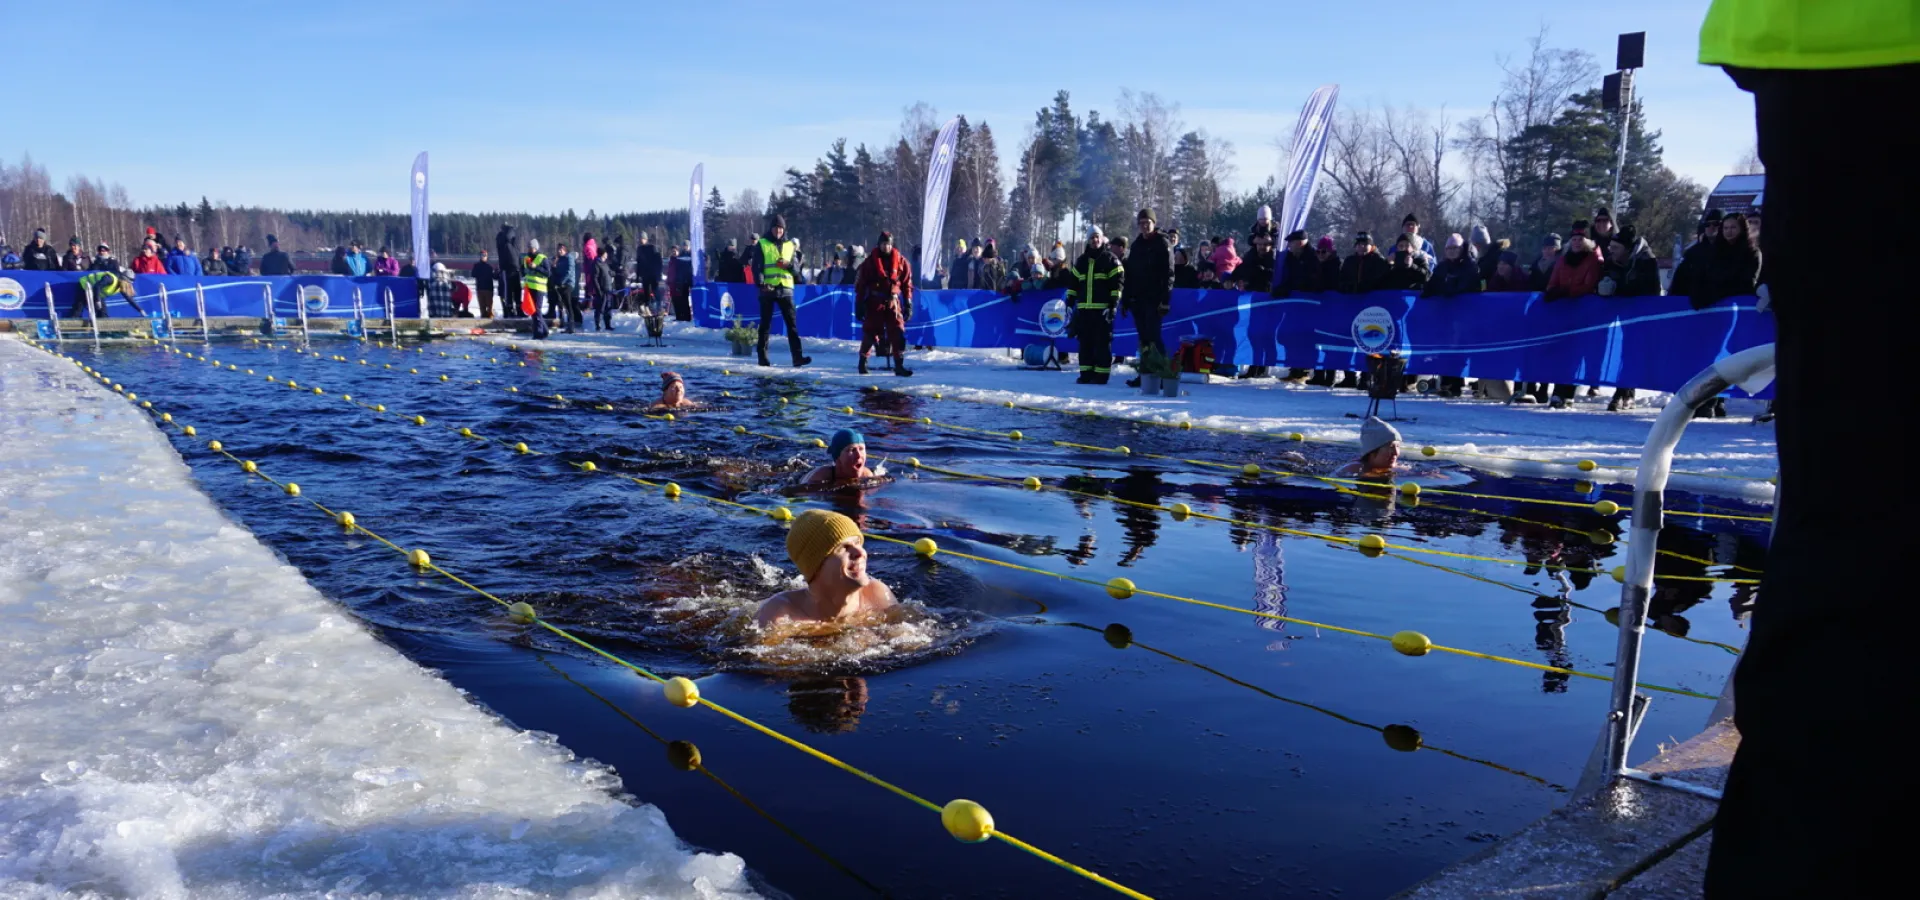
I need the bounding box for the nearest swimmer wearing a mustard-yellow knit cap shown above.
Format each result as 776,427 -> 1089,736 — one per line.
753,509 -> 899,628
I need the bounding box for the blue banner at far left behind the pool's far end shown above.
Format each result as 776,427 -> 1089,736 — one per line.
0,271 -> 420,319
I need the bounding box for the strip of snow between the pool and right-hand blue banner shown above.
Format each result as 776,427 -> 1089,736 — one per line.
486,315 -> 1776,503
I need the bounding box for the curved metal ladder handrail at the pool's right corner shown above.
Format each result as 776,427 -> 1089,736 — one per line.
1601,343 -> 1780,800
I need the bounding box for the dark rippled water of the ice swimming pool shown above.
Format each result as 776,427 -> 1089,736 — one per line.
81,342 -> 1766,898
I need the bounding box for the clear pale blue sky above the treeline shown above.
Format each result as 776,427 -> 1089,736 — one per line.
11,0 -> 1753,213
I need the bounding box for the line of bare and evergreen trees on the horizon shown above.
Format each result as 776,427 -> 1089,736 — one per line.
0,33 -> 1705,270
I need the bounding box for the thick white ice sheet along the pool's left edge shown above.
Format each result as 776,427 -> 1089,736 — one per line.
0,340 -> 751,898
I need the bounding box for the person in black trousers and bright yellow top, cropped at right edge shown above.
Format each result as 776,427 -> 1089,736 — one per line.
1699,8 -> 1920,898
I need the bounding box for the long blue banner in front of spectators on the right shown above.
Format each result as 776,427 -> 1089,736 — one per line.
693,284 -> 1774,391
